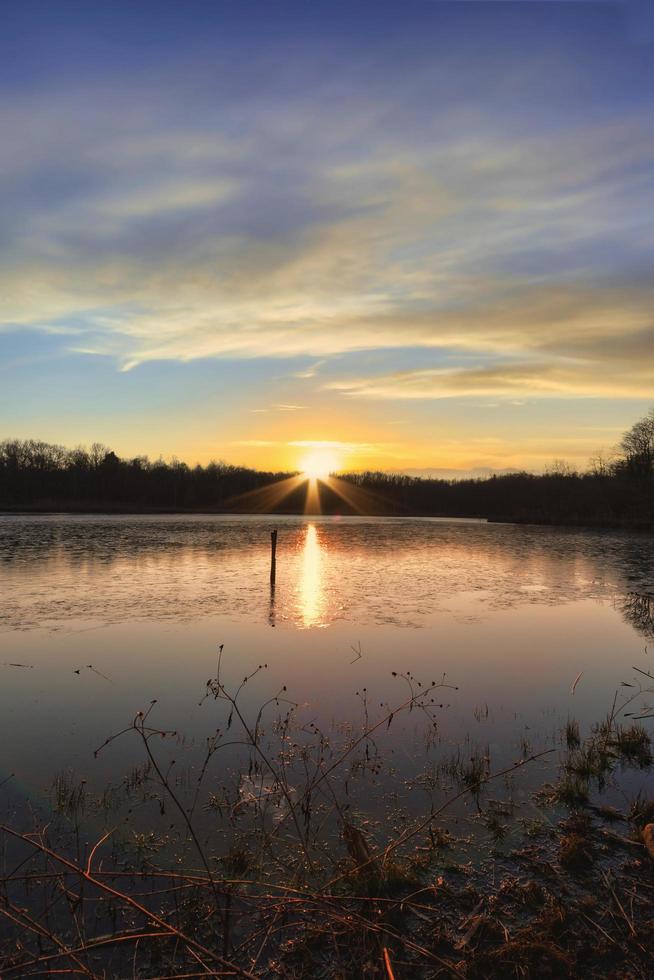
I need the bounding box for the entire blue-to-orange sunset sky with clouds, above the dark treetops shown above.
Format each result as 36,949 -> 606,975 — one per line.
0,0 -> 654,475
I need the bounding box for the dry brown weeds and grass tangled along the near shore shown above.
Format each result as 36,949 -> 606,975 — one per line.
0,648 -> 654,980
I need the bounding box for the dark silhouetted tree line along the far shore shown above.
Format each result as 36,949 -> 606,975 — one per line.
0,409 -> 654,528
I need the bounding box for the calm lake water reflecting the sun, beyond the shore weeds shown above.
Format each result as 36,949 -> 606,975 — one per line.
0,516 -> 654,820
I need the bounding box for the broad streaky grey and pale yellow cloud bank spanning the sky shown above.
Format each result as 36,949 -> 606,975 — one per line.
0,47 -> 654,402
